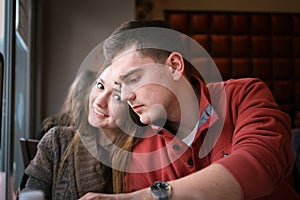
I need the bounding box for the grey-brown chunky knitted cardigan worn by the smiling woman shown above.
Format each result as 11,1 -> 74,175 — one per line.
22,127 -> 112,199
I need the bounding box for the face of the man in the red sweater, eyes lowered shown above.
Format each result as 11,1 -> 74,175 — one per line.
111,51 -> 177,125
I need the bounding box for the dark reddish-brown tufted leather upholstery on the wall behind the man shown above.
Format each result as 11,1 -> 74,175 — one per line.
165,10 -> 300,114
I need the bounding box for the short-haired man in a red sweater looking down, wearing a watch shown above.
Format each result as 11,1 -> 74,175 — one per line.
79,20 -> 299,200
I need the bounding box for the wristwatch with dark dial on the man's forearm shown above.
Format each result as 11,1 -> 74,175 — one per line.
150,181 -> 171,200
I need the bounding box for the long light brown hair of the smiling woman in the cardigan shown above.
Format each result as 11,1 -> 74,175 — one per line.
58,67 -> 142,193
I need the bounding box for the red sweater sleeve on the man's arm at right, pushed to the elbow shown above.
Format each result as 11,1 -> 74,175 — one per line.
217,79 -> 294,199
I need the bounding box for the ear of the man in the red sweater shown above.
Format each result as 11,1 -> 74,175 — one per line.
166,52 -> 184,80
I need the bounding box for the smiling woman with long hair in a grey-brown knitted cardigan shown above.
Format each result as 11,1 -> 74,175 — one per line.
22,68 -> 141,199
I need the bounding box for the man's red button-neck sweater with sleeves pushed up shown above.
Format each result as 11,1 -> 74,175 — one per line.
125,78 -> 300,200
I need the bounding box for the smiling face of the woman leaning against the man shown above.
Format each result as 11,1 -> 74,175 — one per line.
88,67 -> 126,129
